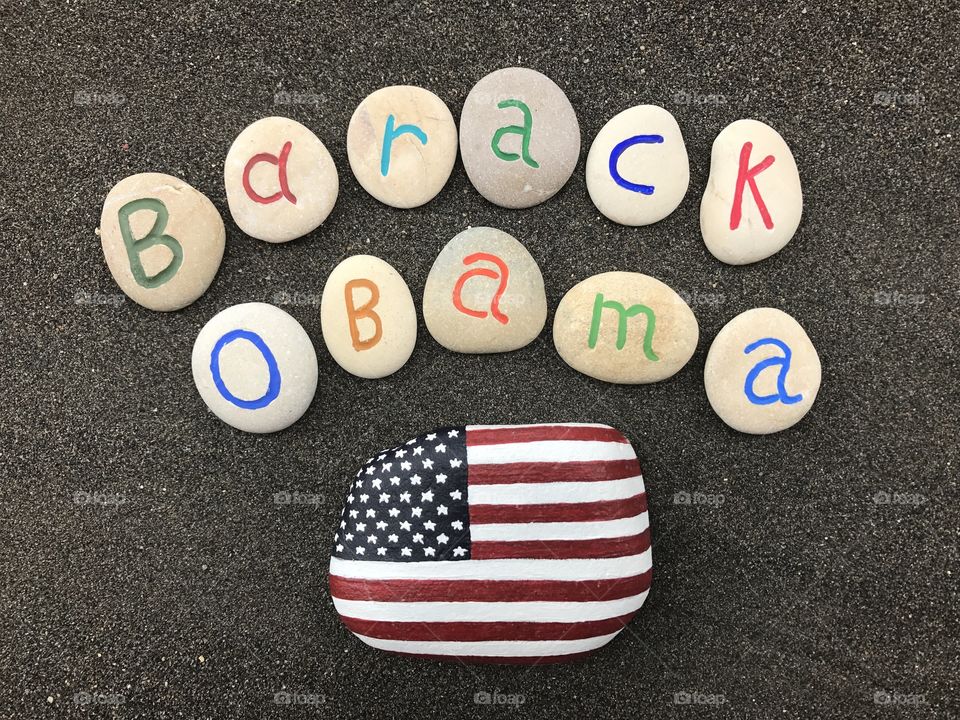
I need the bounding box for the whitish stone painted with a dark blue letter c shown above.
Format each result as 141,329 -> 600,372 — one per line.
586,105 -> 690,226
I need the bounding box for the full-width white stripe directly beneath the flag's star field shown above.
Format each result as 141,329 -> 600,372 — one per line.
330,548 -> 651,580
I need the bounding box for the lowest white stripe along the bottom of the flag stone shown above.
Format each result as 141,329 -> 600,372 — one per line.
354,630 -> 620,657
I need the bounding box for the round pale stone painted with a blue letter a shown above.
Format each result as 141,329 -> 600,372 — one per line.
703,308 -> 821,435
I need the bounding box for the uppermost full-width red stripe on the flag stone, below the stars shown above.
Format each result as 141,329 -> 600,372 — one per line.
330,570 -> 651,602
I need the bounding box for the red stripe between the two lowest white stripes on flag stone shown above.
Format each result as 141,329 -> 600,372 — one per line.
340,613 -> 635,642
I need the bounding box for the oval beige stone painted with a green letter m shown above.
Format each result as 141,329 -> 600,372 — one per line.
553,272 -> 700,384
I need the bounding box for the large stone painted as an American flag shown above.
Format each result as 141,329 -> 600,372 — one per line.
330,424 -> 652,664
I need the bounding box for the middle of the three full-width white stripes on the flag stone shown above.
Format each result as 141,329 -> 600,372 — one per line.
333,590 -> 649,623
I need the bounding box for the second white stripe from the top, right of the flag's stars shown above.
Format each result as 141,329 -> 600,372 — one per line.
467,475 -> 643,505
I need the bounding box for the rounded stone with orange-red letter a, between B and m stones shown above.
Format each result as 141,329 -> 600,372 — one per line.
423,227 -> 547,353
